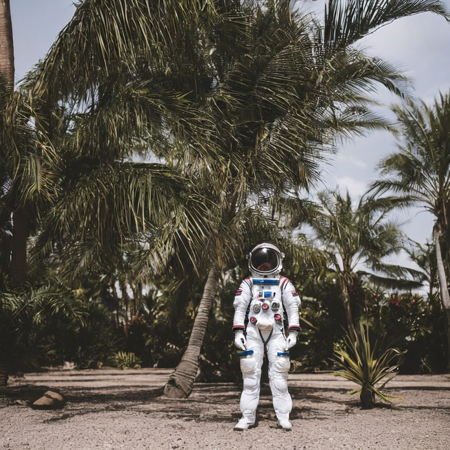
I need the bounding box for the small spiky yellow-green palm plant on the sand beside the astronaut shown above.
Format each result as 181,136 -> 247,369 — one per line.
334,322 -> 406,409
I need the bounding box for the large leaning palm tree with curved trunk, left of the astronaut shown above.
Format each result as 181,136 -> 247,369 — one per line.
161,1 -> 446,396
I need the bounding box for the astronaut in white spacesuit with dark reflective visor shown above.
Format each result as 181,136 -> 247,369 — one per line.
233,243 -> 300,431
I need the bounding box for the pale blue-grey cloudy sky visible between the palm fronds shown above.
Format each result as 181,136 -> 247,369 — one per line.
11,0 -> 450,250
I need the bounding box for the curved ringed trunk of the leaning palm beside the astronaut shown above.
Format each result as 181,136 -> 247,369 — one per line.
164,268 -> 219,398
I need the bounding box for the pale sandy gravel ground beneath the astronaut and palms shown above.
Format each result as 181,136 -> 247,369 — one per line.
0,369 -> 450,450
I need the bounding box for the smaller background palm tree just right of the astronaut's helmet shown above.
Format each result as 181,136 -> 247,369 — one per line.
310,191 -> 421,339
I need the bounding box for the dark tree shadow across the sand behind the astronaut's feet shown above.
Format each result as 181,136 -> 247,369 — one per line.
5,383 -> 444,426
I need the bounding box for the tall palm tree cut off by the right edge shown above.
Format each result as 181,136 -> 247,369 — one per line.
373,94 -> 450,370
